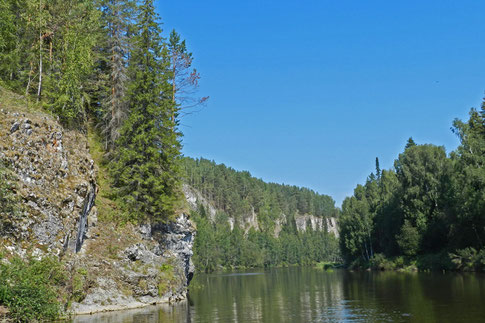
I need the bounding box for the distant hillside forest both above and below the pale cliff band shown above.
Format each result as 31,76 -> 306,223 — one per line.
184,158 -> 340,272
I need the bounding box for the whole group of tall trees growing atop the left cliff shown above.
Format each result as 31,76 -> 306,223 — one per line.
0,0 -> 206,223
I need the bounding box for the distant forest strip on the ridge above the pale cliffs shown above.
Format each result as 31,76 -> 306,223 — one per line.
184,158 -> 337,223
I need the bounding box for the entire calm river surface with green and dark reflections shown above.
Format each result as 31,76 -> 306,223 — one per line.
74,268 -> 485,323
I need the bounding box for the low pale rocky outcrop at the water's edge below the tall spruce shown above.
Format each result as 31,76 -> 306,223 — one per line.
72,214 -> 195,314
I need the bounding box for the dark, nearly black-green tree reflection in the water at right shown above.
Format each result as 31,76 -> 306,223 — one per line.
343,271 -> 485,322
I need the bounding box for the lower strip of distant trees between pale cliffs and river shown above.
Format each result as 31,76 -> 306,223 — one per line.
192,207 -> 340,272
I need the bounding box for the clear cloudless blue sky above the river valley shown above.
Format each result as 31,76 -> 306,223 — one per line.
156,0 -> 485,205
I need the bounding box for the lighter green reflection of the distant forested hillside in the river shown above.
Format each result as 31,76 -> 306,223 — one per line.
187,268 -> 343,322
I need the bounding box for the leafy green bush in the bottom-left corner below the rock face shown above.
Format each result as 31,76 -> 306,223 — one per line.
0,257 -> 66,322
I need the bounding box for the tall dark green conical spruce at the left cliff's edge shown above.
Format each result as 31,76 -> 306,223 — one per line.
112,0 -> 180,220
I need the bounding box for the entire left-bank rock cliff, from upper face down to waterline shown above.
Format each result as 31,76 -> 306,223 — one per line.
0,88 -> 195,313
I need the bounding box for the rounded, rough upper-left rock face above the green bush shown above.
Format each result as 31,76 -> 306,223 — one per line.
0,109 -> 96,255
